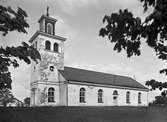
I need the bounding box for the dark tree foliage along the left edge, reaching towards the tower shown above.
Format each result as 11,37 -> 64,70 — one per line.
0,5 -> 40,105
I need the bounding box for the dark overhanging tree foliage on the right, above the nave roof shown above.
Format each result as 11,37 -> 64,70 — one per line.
99,0 -> 167,94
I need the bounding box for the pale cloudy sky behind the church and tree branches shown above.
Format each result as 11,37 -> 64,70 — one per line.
0,0 -> 167,101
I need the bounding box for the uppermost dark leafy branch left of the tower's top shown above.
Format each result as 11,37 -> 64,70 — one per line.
0,5 -> 29,35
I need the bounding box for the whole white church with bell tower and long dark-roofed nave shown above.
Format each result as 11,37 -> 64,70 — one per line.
29,9 -> 149,106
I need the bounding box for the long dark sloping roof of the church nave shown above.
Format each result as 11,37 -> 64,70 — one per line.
59,67 -> 148,90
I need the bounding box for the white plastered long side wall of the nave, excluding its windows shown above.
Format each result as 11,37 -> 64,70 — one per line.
68,84 -> 148,106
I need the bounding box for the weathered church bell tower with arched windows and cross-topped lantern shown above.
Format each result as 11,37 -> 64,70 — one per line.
29,7 -> 66,106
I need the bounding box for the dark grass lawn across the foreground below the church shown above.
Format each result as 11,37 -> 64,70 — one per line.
0,107 -> 167,122
